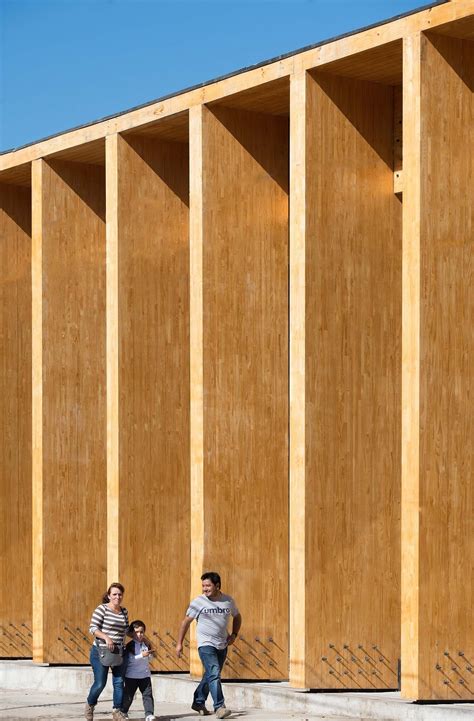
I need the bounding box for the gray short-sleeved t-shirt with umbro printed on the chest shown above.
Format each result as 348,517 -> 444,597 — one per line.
186,593 -> 239,649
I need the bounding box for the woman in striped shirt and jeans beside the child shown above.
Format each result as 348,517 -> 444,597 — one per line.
84,583 -> 128,721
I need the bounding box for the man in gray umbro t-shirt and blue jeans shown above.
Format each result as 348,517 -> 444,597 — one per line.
176,571 -> 242,719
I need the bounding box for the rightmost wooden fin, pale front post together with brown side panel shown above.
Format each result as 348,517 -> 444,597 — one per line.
402,34 -> 474,700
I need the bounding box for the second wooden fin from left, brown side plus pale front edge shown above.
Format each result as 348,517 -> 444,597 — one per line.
32,160 -> 107,663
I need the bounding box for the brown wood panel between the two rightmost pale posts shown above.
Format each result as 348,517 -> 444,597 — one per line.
306,70 -> 401,689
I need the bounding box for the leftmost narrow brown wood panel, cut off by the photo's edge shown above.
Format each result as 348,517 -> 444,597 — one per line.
0,183 -> 32,657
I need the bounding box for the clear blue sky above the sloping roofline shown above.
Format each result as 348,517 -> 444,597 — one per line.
0,0 -> 438,151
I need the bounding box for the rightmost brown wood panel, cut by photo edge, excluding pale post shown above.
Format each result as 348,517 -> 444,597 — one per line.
418,35 -> 474,700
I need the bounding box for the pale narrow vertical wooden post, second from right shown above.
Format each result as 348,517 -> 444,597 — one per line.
289,71 -> 310,688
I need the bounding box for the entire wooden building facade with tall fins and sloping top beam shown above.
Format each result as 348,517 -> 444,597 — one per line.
0,0 -> 474,700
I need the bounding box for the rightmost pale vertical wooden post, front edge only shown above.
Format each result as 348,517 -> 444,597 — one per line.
401,33 -> 421,698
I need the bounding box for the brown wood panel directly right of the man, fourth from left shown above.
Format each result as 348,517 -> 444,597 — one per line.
202,108 -> 288,679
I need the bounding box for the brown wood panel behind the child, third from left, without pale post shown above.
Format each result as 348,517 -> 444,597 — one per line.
118,136 -> 190,671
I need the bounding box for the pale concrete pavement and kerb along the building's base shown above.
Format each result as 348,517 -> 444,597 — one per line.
0,660 -> 474,721
